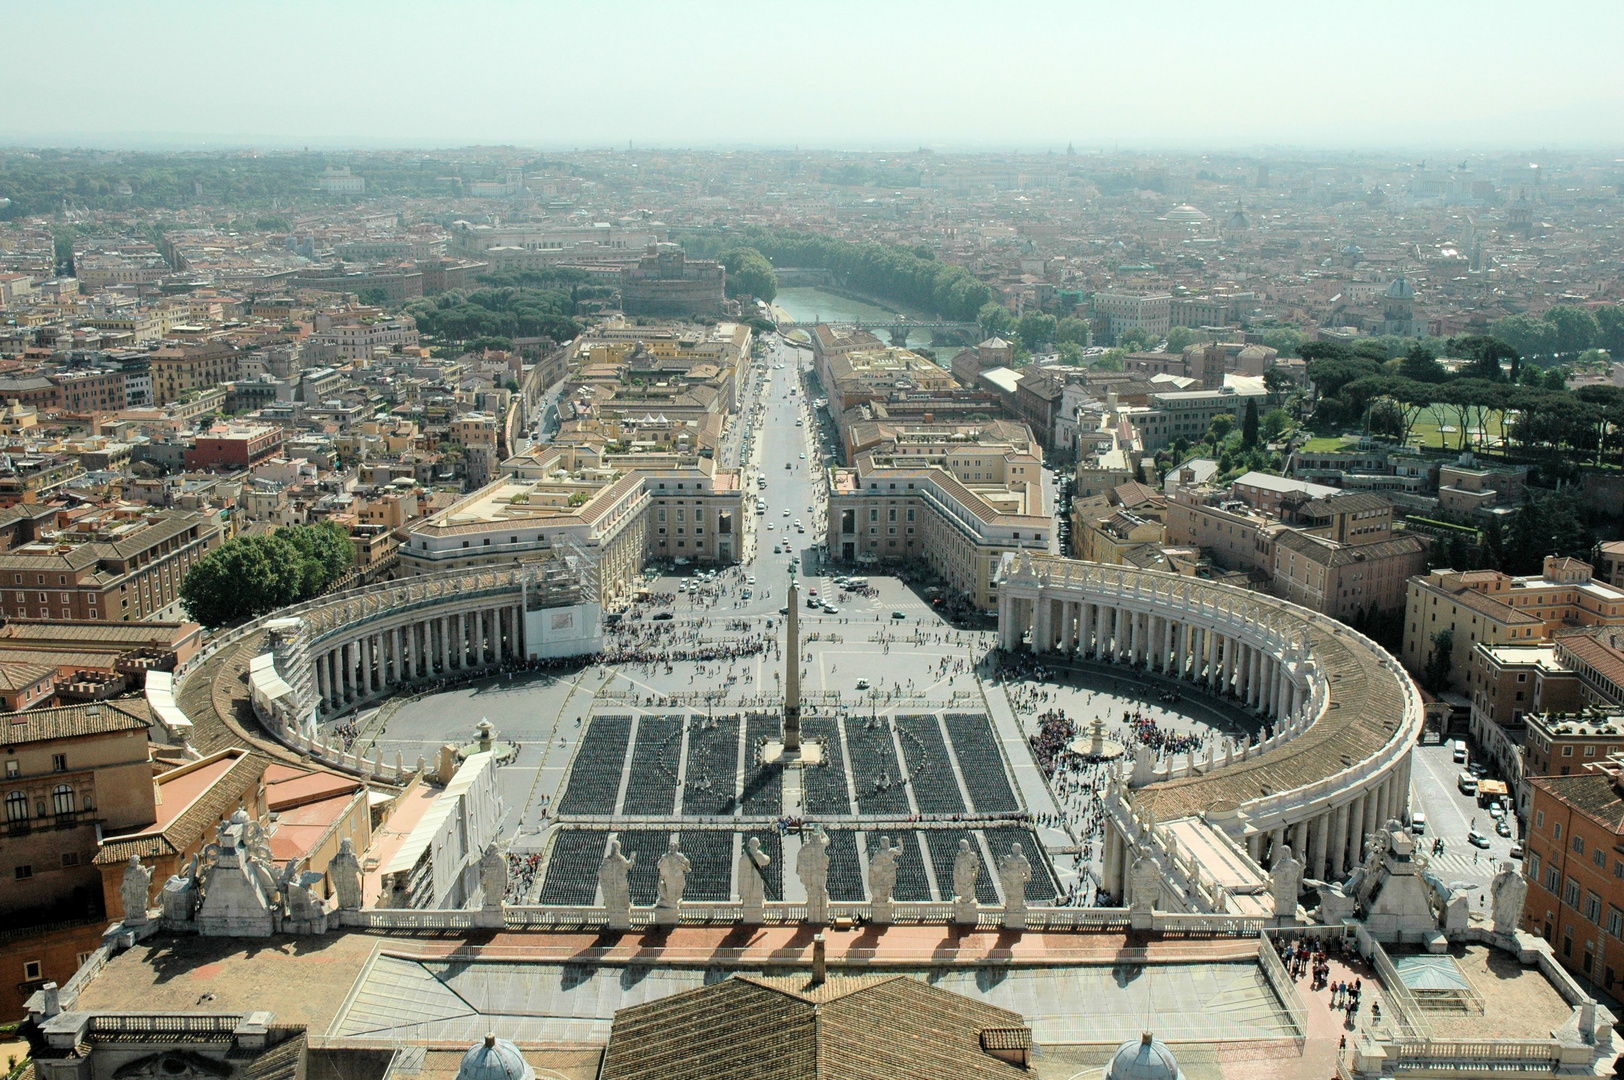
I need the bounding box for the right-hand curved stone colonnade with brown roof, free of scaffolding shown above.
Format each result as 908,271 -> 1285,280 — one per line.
999,554 -> 1423,896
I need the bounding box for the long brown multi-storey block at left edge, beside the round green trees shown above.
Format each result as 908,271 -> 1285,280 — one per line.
0,510 -> 224,622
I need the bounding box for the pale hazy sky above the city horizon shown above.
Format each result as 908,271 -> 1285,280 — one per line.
0,0 -> 1624,149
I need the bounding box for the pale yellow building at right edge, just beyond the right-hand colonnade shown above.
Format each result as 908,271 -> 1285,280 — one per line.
1400,555 -> 1624,695
